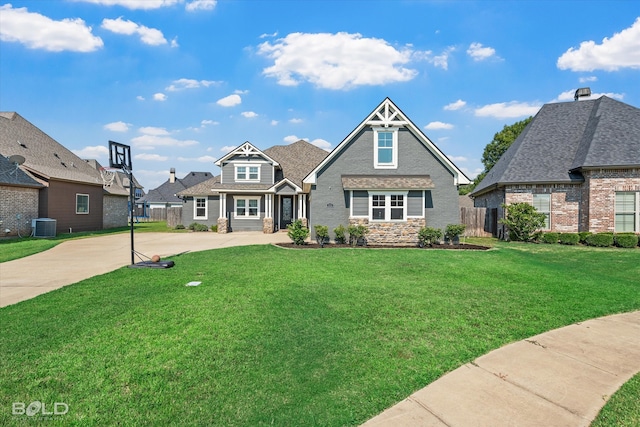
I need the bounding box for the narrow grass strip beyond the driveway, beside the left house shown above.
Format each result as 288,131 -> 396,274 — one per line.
0,221 -> 184,263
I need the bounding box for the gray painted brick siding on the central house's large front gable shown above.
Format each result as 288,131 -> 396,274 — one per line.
310,127 -> 459,239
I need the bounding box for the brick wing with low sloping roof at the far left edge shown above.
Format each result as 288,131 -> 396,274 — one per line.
0,153 -> 44,237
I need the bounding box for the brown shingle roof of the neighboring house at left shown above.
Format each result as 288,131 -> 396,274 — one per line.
0,112 -> 102,185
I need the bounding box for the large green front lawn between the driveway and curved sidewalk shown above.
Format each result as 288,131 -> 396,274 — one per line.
0,243 -> 640,426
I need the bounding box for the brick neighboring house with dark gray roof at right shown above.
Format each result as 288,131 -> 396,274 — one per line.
471,96 -> 640,237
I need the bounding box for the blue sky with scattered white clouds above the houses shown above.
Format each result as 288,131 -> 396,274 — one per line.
0,0 -> 640,189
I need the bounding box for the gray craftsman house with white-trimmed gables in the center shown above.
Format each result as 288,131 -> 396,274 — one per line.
178,98 -> 469,243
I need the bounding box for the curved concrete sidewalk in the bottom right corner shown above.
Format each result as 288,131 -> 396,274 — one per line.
363,311 -> 640,427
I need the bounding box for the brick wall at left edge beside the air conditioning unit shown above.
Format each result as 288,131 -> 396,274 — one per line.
0,185 -> 39,237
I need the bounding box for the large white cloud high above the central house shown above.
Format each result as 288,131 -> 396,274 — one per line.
258,32 -> 418,90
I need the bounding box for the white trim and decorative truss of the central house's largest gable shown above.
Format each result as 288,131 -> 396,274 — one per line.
303,98 -> 471,189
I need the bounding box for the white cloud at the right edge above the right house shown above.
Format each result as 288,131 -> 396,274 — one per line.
557,17 -> 640,71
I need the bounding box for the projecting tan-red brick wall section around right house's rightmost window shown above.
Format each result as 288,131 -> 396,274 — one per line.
583,168 -> 640,233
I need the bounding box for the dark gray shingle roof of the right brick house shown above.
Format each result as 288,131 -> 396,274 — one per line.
472,96 -> 640,195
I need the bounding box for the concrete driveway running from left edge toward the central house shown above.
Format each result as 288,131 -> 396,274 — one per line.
0,232 -> 291,307
